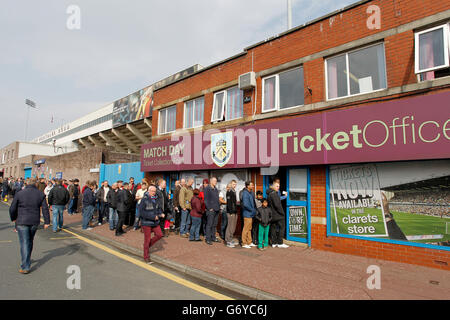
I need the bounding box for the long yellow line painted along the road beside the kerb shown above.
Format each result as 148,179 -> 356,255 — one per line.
63,230 -> 234,300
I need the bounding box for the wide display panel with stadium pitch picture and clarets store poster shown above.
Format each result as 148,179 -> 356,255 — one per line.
330,160 -> 450,246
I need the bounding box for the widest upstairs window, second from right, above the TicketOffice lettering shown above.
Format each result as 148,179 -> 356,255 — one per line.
325,43 -> 387,100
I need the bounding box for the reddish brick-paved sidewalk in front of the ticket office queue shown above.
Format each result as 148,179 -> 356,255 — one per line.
58,213 -> 450,300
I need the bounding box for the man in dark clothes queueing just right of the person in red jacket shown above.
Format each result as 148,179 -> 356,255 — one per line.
204,177 -> 220,245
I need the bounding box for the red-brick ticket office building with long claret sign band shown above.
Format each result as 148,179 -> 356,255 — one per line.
141,0 -> 450,268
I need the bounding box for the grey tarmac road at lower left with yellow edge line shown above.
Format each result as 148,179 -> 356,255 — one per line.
0,203 -> 242,300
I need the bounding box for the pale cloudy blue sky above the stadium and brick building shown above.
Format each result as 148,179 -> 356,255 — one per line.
0,0 -> 356,148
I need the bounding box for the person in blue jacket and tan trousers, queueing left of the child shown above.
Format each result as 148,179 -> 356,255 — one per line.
241,181 -> 256,249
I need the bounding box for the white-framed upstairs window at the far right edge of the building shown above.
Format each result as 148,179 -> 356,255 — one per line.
415,24 -> 450,80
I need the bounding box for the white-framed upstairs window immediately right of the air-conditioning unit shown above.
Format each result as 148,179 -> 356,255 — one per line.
263,67 -> 305,112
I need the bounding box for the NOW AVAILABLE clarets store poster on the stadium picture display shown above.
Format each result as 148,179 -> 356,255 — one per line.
330,164 -> 388,237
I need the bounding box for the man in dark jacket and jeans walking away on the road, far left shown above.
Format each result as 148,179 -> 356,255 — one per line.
9,178 -> 50,274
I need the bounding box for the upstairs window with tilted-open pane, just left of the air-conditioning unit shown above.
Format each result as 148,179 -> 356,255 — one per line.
211,87 -> 244,122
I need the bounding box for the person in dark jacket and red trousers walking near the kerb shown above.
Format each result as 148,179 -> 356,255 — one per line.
138,186 -> 164,263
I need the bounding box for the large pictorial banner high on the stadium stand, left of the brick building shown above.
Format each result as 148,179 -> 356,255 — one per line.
113,86 -> 153,128
